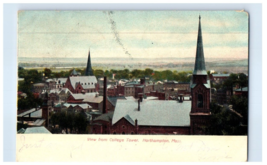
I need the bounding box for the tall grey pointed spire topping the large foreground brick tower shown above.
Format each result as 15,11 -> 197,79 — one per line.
193,15 -> 207,75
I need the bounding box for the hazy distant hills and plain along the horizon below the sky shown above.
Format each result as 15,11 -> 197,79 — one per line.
18,57 -> 248,72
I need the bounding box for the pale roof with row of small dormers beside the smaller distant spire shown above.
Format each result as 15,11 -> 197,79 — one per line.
70,76 -> 97,89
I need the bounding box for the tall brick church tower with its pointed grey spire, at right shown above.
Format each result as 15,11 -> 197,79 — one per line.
190,16 -> 210,135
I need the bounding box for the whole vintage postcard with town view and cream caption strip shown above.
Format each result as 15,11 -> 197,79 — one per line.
16,10 -> 249,162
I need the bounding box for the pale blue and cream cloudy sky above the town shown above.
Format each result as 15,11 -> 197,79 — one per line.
18,11 -> 248,59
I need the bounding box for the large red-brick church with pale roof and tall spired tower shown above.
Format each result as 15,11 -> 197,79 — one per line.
92,16 -> 211,135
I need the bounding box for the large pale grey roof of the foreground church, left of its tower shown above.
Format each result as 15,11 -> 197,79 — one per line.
112,100 -> 191,127
